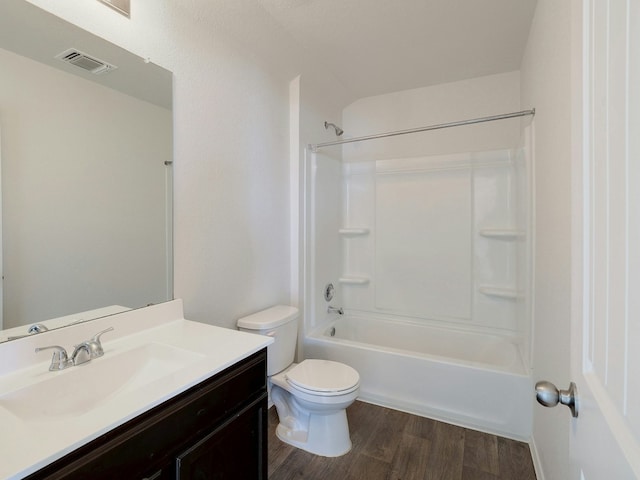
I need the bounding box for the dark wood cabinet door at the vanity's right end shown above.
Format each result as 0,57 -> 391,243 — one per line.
176,395 -> 267,480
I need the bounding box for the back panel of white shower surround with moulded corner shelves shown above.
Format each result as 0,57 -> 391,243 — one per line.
337,150 -> 527,335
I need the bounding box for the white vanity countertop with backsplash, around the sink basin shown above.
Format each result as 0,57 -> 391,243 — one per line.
0,300 -> 273,479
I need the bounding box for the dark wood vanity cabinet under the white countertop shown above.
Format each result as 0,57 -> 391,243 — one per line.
27,349 -> 267,480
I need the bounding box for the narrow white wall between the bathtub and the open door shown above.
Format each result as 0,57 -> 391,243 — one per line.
521,0 -> 572,479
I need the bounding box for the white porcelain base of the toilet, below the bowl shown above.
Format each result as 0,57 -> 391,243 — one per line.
276,405 -> 351,457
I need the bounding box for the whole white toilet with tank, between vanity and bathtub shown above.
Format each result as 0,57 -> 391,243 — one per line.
238,305 -> 360,457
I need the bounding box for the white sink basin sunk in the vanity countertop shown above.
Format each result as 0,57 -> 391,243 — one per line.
0,343 -> 204,421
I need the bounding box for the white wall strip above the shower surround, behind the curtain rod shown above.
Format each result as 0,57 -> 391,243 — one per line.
342,72 -> 529,161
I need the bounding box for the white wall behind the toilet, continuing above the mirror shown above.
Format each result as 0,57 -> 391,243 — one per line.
23,0 -> 350,327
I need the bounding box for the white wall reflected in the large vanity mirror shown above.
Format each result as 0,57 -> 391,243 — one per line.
0,45 -> 172,327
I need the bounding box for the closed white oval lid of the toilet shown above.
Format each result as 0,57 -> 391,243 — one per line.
285,360 -> 360,392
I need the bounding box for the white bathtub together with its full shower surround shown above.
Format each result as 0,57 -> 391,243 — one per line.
303,143 -> 532,440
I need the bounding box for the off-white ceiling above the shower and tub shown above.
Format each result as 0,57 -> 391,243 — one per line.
258,0 -> 536,98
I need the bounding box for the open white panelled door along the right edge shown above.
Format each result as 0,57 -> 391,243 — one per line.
572,0 -> 640,480
